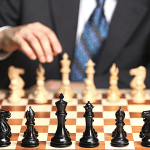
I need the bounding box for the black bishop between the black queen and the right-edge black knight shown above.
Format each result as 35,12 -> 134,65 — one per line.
111,107 -> 129,147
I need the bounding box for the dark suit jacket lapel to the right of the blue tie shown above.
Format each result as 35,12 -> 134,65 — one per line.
97,0 -> 148,74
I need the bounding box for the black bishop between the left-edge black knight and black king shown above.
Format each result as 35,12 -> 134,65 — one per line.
21,106 -> 39,147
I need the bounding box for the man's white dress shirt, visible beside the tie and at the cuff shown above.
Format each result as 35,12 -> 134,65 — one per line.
0,0 -> 117,60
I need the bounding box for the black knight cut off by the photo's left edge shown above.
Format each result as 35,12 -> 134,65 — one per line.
0,109 -> 11,147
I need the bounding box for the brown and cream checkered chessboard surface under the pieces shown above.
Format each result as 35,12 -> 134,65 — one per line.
0,90 -> 150,150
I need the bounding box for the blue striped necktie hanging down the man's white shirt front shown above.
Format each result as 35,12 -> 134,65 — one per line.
70,0 -> 109,81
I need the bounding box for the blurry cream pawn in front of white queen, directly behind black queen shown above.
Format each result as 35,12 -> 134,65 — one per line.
83,79 -> 96,103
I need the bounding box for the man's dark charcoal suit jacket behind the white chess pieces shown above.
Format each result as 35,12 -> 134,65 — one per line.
0,0 -> 150,88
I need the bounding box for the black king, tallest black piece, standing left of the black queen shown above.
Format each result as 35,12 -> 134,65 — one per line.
50,93 -> 72,147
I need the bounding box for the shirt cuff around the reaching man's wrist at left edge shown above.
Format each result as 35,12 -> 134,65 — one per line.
0,26 -> 12,61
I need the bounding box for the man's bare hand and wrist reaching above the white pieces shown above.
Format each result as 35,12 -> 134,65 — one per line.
0,22 -> 62,63
